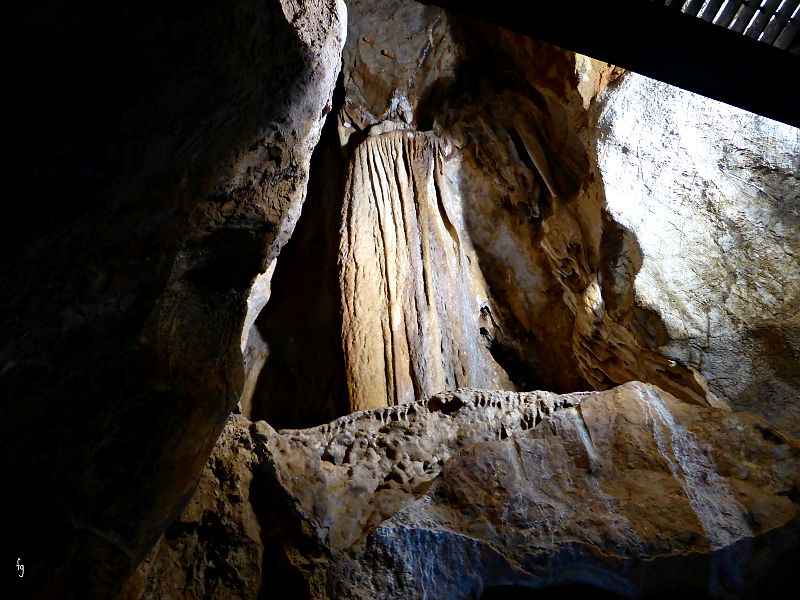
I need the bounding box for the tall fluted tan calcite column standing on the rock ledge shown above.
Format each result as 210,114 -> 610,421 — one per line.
339,130 -> 511,410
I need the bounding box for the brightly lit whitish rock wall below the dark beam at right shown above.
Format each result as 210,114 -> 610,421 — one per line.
596,75 -> 800,435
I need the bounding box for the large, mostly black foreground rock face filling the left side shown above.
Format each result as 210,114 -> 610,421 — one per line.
0,0 -> 345,598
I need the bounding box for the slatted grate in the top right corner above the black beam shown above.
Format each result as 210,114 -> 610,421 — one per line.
651,0 -> 800,50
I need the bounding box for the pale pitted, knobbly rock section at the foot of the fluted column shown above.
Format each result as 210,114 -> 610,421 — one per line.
269,389 -> 580,553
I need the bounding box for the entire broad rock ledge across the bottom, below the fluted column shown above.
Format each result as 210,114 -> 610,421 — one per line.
138,382 -> 800,599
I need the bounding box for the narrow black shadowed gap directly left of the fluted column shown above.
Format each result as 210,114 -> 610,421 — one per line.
249,76 -> 349,429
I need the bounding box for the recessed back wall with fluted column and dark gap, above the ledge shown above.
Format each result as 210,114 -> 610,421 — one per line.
247,0 -> 718,426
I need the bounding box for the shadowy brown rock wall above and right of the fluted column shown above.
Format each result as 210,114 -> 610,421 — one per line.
339,0 -> 716,406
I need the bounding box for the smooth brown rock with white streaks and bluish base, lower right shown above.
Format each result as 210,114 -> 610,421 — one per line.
342,383 -> 800,598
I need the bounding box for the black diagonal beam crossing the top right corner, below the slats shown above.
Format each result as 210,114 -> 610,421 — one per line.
423,0 -> 800,127
